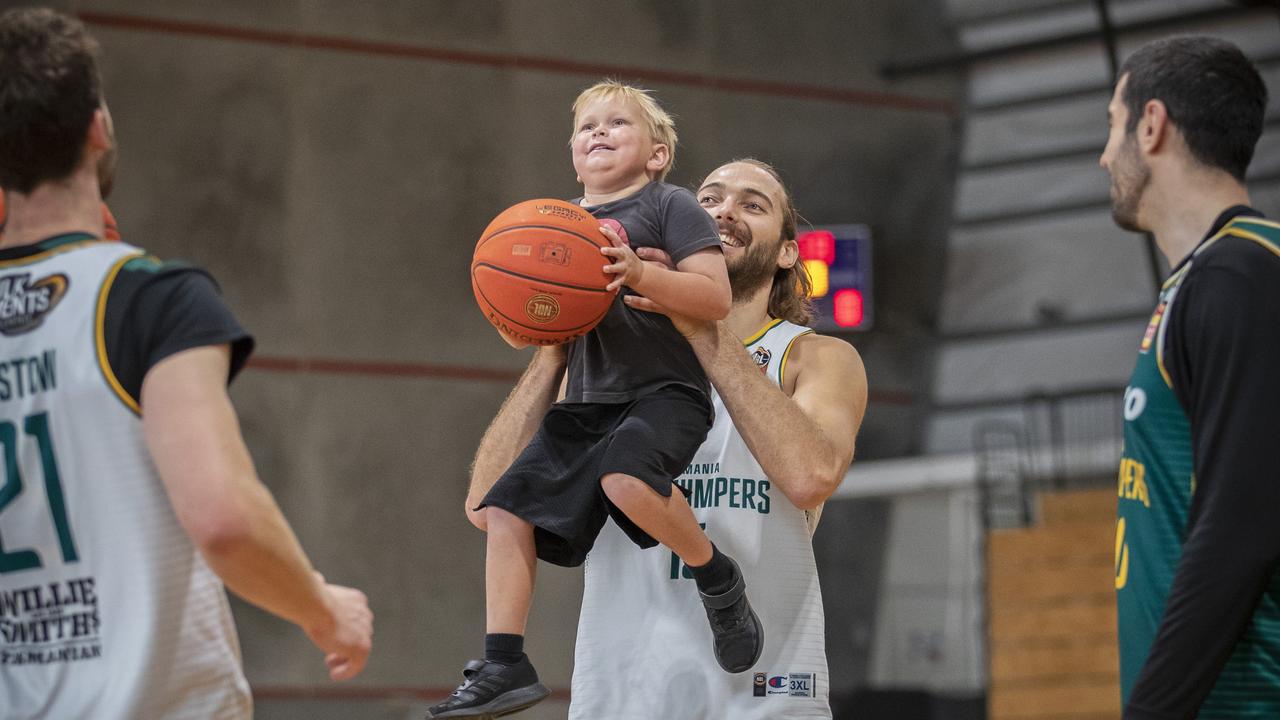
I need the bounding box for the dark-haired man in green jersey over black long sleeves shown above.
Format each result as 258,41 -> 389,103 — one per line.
1101,37 -> 1280,720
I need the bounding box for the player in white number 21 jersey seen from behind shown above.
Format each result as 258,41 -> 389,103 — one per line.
0,9 -> 372,720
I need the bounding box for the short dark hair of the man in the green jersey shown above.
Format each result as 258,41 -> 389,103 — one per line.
1120,36 -> 1267,182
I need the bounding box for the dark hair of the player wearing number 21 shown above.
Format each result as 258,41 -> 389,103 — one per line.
0,8 -> 102,195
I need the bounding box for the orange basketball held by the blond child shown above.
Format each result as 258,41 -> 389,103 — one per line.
471,199 -> 617,345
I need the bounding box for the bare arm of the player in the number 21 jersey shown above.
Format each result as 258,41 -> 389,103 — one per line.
142,345 -> 372,680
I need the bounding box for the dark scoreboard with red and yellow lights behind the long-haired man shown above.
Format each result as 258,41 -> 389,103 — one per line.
796,224 -> 872,332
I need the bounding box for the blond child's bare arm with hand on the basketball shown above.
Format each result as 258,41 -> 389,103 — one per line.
600,227 -> 732,320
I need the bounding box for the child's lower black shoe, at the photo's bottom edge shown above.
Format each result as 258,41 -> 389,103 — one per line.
426,657 -> 552,719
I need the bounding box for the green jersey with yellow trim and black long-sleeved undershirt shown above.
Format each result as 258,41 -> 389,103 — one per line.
1115,206 -> 1280,719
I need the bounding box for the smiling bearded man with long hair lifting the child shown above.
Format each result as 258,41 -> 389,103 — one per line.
467,160 -> 867,720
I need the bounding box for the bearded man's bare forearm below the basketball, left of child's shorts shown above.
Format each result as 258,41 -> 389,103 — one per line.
465,345 -> 566,530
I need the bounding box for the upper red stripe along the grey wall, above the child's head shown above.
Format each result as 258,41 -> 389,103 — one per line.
79,12 -> 956,115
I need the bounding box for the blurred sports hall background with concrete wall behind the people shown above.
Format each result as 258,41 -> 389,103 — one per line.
27,0 -> 1280,720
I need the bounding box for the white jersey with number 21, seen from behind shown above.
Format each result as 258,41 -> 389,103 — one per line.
0,236 -> 252,720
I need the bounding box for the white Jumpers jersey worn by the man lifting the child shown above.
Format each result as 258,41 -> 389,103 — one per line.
570,320 -> 831,720
